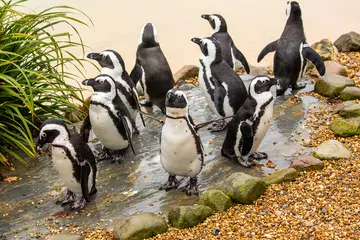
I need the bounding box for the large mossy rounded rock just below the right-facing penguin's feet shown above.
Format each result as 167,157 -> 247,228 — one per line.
219,173 -> 266,204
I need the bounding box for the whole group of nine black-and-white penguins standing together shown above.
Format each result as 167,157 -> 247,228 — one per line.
36,1 -> 325,210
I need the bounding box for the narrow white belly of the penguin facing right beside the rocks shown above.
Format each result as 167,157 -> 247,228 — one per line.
249,102 -> 273,154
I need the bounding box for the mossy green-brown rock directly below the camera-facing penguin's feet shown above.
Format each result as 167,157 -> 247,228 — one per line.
168,204 -> 213,229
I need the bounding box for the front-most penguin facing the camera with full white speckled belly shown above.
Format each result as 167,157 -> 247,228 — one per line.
160,88 -> 204,195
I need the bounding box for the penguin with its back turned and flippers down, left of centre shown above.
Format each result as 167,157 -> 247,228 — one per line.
130,23 -> 175,114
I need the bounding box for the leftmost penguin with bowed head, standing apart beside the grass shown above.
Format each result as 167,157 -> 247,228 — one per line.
36,119 -> 97,211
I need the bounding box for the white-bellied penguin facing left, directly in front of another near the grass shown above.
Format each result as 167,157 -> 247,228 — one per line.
82,74 -> 135,163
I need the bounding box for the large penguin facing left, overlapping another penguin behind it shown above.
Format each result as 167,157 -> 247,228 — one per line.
191,37 -> 247,132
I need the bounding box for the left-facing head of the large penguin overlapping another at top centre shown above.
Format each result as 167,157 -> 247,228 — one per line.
191,37 -> 222,62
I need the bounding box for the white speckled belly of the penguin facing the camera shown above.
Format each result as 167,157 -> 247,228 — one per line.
160,119 -> 202,177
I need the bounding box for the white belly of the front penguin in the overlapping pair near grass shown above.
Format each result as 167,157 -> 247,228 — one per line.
89,104 -> 132,150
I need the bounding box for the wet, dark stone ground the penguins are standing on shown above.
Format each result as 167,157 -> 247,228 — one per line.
0,77 -> 318,239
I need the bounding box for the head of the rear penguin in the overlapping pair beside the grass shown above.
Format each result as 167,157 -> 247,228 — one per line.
87,50 -> 125,73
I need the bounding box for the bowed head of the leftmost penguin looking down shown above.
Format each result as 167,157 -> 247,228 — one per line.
36,119 -> 69,151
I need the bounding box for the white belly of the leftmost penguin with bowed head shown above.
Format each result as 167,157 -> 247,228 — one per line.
51,147 -> 82,193
